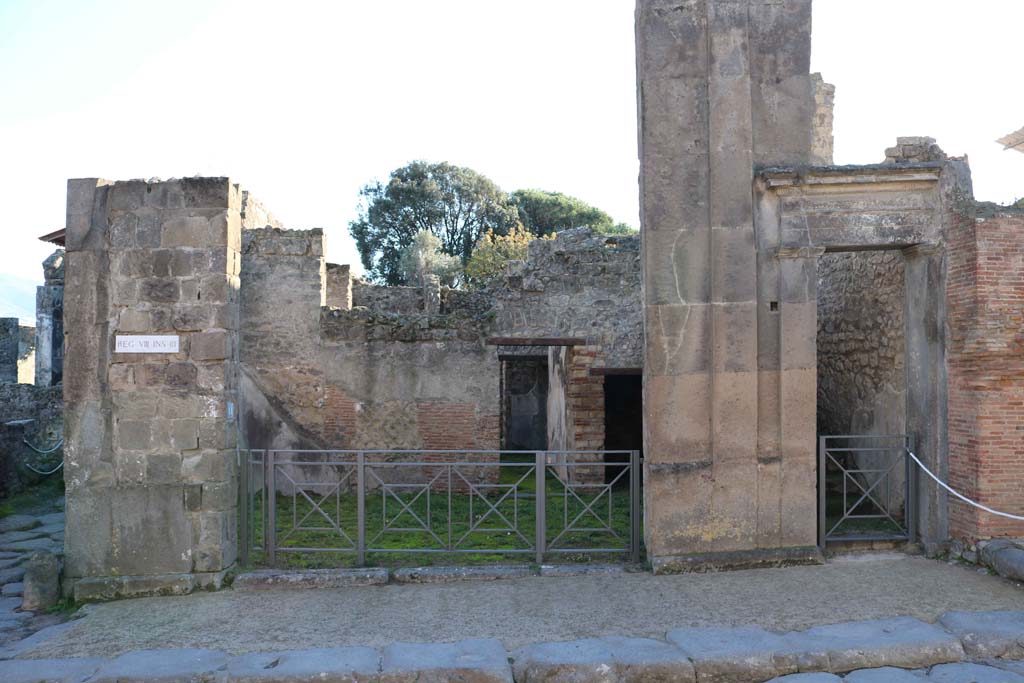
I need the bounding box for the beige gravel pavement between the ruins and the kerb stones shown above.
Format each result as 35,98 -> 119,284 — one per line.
22,554 -> 1024,658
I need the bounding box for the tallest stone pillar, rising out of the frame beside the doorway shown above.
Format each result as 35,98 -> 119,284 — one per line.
637,0 -> 816,571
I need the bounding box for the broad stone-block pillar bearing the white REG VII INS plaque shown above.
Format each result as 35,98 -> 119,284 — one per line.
63,178 -> 241,600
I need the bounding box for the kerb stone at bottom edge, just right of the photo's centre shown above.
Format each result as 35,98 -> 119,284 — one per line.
512,637 -> 694,683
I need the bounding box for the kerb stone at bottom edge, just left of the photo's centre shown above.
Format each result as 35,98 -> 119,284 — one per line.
381,638 -> 512,683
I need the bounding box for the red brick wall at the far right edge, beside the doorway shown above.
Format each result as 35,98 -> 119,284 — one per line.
942,210 -> 1024,541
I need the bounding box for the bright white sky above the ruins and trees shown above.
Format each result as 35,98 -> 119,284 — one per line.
0,0 -> 1024,324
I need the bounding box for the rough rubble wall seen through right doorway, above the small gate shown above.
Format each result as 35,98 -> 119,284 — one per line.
817,251 -> 906,435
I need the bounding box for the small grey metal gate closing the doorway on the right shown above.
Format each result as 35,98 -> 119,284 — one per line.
818,434 -> 916,548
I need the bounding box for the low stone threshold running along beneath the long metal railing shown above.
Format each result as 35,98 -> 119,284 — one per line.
231,564 -> 644,591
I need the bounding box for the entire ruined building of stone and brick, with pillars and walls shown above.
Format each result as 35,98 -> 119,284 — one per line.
0,0 -> 1024,600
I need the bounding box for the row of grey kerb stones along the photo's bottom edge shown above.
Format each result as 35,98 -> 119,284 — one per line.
0,611 -> 1024,683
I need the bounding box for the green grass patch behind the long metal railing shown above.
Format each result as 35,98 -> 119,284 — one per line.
242,456 -> 630,568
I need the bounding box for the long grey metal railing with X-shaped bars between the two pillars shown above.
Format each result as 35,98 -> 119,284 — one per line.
239,449 -> 642,566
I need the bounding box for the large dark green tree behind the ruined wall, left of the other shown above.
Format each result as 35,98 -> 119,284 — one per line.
348,161 -> 519,285
